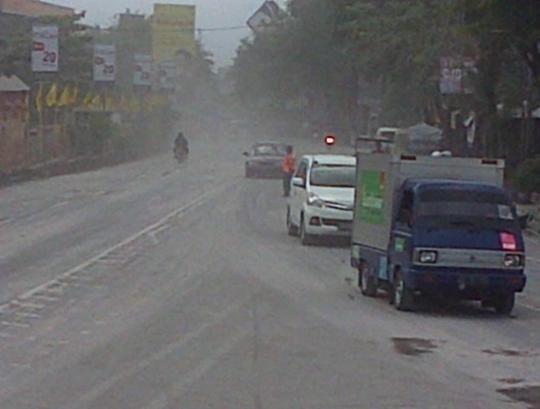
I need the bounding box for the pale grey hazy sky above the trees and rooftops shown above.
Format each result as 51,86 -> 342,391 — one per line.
57,0 -> 285,65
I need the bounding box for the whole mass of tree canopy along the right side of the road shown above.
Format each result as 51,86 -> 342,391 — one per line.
233,0 -> 540,159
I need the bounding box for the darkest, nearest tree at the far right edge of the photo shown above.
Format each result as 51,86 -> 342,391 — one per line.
459,0 -> 540,160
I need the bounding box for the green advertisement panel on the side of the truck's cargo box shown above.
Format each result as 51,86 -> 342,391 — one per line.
358,170 -> 386,224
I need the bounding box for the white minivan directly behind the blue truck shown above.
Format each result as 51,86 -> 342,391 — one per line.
287,155 -> 356,245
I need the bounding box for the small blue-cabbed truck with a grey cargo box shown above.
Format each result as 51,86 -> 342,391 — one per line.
351,149 -> 526,314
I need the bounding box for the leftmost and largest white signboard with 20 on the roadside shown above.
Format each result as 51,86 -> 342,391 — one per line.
32,25 -> 58,72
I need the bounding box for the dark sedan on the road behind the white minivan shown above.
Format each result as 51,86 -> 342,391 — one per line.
244,142 -> 288,178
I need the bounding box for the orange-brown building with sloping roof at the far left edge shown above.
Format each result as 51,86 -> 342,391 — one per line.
0,75 -> 30,173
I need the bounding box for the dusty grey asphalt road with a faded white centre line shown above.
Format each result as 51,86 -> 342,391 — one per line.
0,131 -> 540,409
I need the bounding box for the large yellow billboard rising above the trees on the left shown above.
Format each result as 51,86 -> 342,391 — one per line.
152,4 -> 196,64
